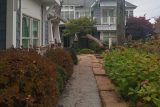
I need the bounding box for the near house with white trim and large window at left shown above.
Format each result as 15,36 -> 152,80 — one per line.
0,0 -> 59,49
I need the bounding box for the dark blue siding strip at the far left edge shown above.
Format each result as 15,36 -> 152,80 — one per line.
0,0 -> 7,49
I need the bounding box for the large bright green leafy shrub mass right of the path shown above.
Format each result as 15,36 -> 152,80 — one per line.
104,48 -> 160,107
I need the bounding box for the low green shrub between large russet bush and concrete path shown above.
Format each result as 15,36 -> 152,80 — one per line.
56,66 -> 67,94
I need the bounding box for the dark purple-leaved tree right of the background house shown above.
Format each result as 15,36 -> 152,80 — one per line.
126,17 -> 153,40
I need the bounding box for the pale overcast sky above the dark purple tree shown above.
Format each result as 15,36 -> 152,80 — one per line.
126,0 -> 160,22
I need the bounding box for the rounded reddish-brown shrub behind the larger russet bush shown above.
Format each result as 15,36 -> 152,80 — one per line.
45,48 -> 73,77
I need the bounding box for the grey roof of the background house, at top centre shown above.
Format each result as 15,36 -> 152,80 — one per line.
63,0 -> 96,7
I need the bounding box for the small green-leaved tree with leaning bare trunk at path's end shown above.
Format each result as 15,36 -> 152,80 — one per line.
64,17 -> 104,48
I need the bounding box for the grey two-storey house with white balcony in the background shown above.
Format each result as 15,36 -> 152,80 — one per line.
61,0 -> 136,47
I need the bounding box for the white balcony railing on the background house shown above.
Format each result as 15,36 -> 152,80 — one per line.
101,16 -> 117,25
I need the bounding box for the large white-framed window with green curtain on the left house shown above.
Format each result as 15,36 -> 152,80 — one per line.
22,16 -> 39,48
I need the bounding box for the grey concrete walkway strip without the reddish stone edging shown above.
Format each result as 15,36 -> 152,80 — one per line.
58,55 -> 102,107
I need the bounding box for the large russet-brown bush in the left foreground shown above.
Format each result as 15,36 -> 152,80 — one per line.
0,49 -> 57,107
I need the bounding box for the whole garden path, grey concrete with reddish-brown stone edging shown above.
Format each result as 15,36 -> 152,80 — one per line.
57,55 -> 127,107
